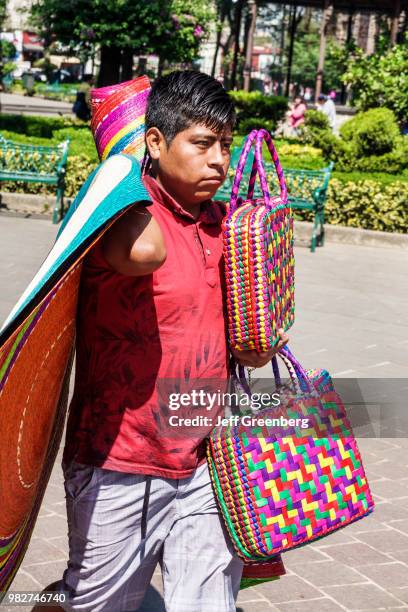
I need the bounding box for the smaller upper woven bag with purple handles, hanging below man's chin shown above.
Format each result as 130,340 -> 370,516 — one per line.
223,129 -> 295,351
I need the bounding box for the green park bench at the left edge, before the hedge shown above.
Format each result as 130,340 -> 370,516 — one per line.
0,135 -> 69,223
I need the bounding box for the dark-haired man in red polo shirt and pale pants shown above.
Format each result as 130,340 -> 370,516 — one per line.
61,71 -> 288,612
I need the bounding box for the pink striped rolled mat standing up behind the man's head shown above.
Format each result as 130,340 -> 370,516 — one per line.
91,76 -> 151,162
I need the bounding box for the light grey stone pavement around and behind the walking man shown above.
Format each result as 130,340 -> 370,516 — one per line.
0,215 -> 408,612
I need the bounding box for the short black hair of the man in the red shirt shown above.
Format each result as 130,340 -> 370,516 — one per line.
145,70 -> 235,146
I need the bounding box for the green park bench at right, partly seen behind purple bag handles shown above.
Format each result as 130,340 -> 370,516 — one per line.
214,149 -> 334,253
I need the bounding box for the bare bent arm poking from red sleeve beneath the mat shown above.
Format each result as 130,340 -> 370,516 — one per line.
102,205 -> 166,276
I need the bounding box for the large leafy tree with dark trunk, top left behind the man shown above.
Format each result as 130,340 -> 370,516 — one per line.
31,0 -> 215,86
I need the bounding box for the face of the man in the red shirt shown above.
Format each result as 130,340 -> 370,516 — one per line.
147,124 -> 232,206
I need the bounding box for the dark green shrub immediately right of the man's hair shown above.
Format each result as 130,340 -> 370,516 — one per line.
229,91 -> 288,133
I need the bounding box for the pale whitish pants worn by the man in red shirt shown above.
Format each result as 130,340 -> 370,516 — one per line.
60,462 -> 243,612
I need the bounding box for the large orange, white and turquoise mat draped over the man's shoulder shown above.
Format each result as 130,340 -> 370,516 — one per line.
0,155 -> 149,600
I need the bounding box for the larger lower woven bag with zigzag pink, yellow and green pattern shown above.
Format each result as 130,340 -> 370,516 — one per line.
207,347 -> 374,561
